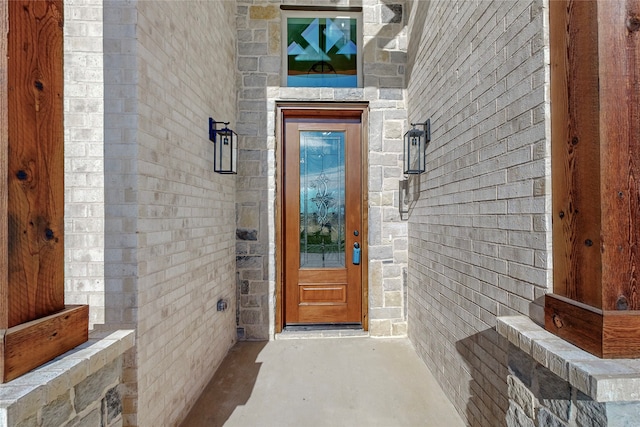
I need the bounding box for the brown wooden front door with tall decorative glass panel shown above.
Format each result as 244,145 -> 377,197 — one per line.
282,112 -> 366,326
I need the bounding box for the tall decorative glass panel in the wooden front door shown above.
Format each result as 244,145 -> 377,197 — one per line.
300,131 -> 345,268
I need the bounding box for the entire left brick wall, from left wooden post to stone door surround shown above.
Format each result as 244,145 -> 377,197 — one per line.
75,0 -> 236,426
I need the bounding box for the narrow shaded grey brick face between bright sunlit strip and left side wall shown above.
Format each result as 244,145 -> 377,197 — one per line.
103,0 -> 138,426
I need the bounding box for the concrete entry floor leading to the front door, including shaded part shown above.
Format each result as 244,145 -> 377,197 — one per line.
182,337 -> 464,427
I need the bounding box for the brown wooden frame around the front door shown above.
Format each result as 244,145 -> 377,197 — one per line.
275,102 -> 369,333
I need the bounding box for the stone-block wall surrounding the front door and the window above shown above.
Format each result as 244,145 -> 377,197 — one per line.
236,0 -> 407,339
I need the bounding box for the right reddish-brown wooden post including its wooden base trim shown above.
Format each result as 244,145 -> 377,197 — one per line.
545,0 -> 640,358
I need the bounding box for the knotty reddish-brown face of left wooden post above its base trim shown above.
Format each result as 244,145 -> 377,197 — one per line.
8,0 -> 64,327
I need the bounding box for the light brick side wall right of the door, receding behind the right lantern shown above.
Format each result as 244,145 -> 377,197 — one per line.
407,0 -> 551,427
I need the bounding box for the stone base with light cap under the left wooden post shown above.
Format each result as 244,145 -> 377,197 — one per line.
0,331 -> 134,427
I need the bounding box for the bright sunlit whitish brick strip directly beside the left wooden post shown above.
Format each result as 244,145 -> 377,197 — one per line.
64,0 -> 105,326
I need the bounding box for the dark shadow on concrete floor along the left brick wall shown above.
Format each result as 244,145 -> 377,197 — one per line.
181,341 -> 267,427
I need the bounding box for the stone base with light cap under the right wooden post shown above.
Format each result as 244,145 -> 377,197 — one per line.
497,316 -> 640,427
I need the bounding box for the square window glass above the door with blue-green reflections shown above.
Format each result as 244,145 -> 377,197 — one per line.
287,18 -> 358,87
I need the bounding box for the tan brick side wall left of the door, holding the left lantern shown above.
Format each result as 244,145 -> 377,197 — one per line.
134,0 -> 236,426
